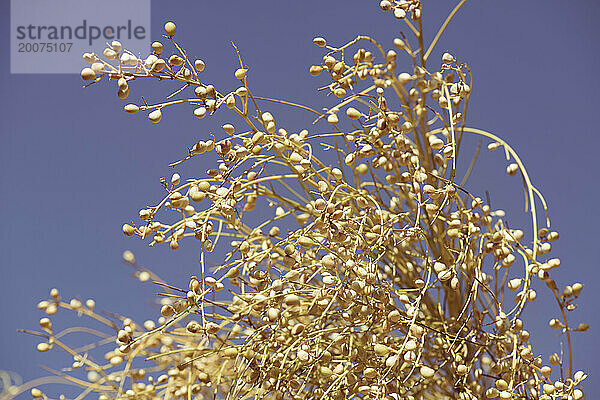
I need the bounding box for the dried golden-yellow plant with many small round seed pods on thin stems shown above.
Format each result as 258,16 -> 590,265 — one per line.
5,0 -> 588,400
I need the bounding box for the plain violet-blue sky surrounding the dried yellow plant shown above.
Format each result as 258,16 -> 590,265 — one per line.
0,0 -> 600,399
